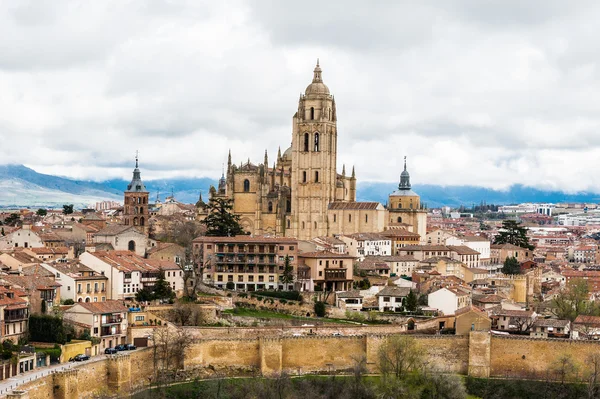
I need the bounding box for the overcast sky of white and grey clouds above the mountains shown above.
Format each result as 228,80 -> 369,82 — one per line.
0,0 -> 600,192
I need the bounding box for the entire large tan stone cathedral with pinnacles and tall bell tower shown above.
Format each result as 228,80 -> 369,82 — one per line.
210,61 -> 424,240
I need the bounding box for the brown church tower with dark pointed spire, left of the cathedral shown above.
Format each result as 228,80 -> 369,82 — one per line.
123,155 -> 149,234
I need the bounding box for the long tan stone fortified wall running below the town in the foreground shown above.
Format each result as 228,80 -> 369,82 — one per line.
9,332 -> 600,399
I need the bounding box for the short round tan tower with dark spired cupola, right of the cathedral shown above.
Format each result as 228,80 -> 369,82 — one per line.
388,157 -> 427,239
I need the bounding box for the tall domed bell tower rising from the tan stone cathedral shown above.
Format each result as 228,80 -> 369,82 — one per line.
286,60 -> 337,239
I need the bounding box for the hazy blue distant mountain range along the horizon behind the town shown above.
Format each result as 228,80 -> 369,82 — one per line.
0,165 -> 600,208
